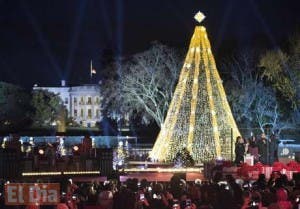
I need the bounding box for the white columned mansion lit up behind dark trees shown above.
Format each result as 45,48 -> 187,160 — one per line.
33,80 -> 102,127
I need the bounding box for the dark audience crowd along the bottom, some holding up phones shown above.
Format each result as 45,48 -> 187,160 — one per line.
0,172 -> 300,209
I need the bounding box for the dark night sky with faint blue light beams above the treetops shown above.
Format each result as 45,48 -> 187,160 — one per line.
0,0 -> 300,88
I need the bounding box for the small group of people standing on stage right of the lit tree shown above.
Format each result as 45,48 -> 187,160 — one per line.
235,133 -> 279,165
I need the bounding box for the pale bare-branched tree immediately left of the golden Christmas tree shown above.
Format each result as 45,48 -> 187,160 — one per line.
102,43 -> 182,126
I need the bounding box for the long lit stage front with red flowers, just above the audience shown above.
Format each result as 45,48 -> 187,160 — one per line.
18,160 -> 300,182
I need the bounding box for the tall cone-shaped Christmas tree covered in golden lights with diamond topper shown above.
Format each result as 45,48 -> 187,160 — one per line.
150,12 -> 240,162
